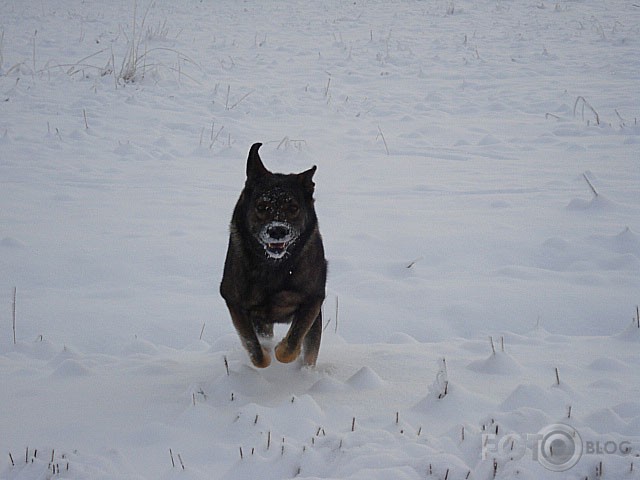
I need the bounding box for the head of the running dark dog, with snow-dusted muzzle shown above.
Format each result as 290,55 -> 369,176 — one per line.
234,143 -> 316,261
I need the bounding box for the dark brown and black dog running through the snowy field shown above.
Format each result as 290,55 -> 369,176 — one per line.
220,143 -> 327,368
